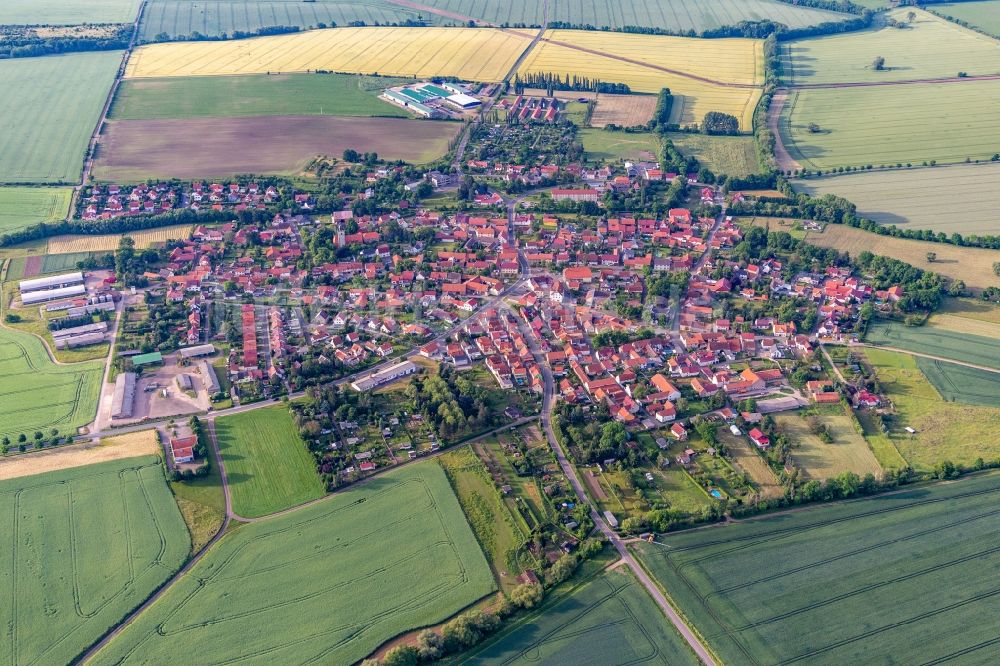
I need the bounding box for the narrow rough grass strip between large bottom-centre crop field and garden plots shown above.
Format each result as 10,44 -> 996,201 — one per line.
438,446 -> 527,588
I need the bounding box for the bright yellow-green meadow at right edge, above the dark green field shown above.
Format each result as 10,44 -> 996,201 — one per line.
864,349 -> 1000,471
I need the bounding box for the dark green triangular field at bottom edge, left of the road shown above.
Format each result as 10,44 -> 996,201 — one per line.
463,567 -> 699,666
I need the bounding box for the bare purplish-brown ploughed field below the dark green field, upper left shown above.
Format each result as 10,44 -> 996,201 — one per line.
95,116 -> 462,180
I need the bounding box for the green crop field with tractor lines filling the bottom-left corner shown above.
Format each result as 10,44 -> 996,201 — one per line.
0,457 -> 190,666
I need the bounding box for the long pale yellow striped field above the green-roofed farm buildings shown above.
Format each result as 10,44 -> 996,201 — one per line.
125,28 -> 531,82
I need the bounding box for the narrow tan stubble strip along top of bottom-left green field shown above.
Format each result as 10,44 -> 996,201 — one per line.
0,430 -> 162,481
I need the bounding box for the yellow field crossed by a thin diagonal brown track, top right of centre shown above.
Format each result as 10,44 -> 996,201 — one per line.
519,30 -> 764,131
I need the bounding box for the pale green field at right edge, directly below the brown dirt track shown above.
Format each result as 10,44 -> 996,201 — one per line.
779,79 -> 1000,170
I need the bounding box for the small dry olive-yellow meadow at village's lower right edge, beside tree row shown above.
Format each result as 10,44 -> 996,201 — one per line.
774,405 -> 882,481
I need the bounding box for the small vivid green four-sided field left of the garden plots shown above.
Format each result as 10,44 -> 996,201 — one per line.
215,405 -> 323,518
